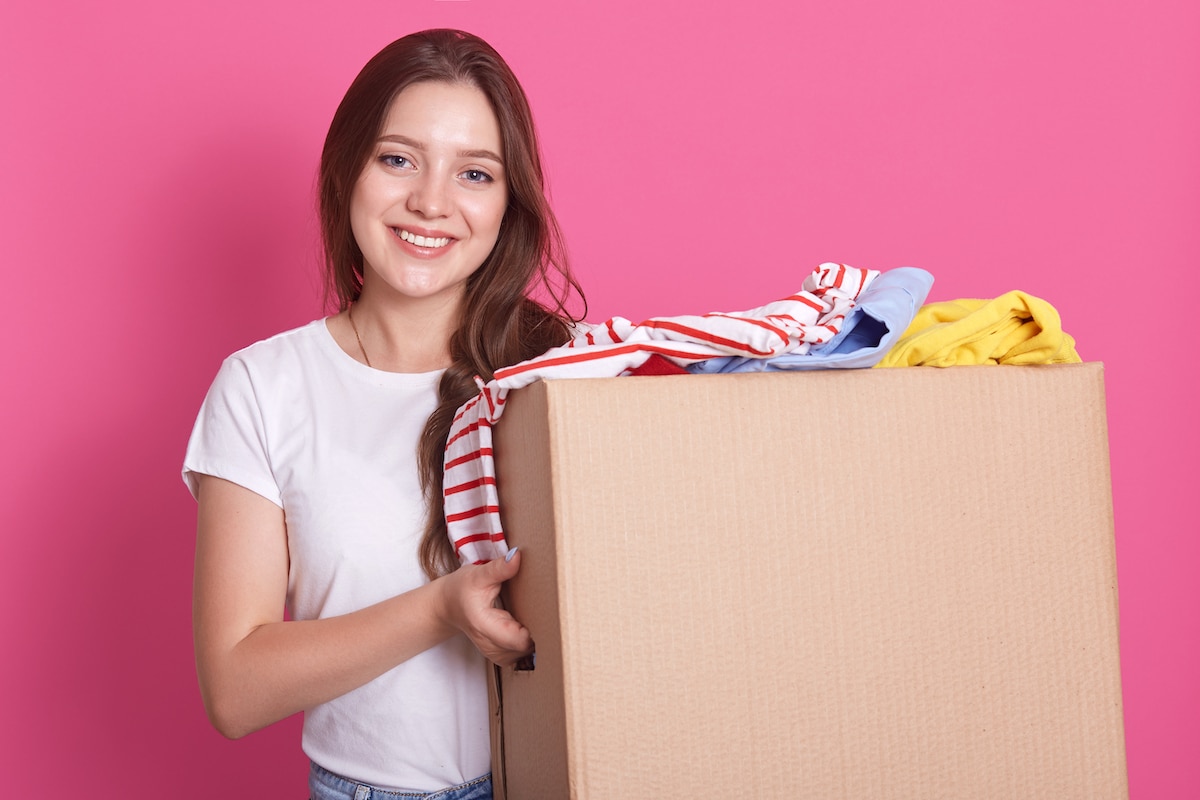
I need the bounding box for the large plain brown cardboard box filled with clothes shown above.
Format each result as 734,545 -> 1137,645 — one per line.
493,363 -> 1128,800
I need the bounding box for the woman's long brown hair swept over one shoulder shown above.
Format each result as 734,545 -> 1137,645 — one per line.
318,30 -> 587,579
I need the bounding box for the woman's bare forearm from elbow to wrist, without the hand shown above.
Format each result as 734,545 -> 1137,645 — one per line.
197,582 -> 457,738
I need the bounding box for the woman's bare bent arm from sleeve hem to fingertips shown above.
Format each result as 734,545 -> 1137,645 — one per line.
192,475 -> 533,738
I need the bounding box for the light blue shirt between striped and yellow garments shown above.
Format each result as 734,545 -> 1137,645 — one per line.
688,266 -> 934,374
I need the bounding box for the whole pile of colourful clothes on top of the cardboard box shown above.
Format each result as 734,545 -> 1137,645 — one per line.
444,264 -> 1080,564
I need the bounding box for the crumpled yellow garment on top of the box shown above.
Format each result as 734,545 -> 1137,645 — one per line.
876,291 -> 1081,367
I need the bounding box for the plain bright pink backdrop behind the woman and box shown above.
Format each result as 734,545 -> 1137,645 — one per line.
0,0 -> 1200,799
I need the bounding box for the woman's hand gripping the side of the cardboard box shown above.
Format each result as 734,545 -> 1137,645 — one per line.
436,548 -> 533,666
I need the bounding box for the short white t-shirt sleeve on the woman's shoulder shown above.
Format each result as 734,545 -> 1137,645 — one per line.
184,355 -> 283,507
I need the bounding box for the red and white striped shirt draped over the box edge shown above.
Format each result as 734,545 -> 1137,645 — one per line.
443,264 -> 878,564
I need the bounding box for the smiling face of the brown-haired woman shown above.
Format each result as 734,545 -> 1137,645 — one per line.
350,83 -> 509,303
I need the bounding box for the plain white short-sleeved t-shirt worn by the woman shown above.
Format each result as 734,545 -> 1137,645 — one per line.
184,320 -> 490,792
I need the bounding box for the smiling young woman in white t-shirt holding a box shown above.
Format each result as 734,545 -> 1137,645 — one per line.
184,30 -> 578,800
